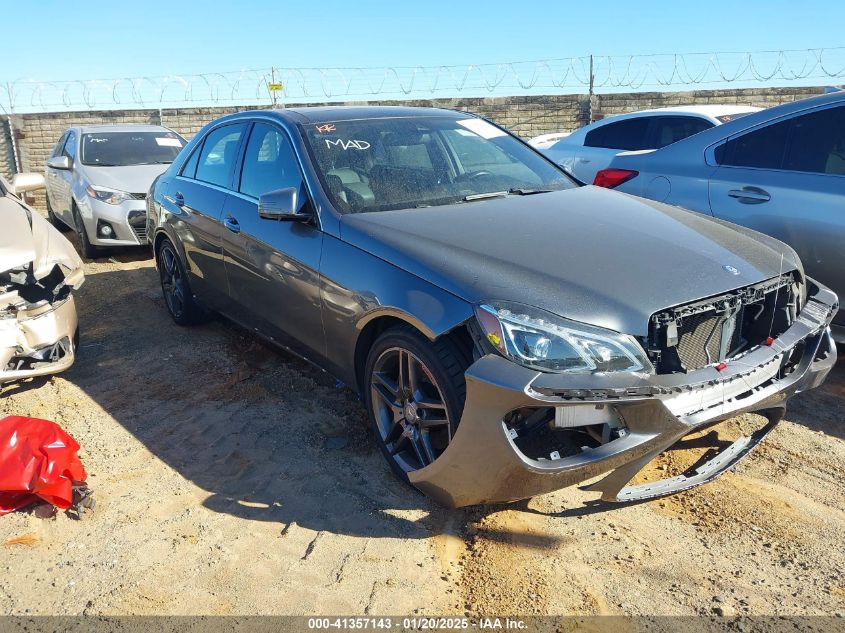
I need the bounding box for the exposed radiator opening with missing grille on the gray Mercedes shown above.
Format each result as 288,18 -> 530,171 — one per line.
647,273 -> 800,373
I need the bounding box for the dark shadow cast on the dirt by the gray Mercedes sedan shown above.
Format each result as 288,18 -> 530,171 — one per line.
12,266 -> 845,547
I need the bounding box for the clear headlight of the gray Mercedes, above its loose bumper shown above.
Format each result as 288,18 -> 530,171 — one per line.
475,301 -> 654,373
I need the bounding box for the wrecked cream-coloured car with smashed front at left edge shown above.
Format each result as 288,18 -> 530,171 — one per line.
0,174 -> 85,382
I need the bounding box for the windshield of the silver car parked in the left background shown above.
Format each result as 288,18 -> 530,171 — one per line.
81,130 -> 185,167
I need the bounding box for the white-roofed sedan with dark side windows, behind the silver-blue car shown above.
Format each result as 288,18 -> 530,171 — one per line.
532,105 -> 760,184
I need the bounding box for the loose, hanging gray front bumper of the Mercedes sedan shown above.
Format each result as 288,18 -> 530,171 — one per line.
409,278 -> 838,507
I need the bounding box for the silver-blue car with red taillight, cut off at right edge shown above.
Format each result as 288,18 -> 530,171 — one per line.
596,92 -> 845,343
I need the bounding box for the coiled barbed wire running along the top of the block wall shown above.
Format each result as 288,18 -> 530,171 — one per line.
0,47 -> 845,114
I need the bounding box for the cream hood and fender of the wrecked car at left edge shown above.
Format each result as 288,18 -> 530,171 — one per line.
0,190 -> 84,288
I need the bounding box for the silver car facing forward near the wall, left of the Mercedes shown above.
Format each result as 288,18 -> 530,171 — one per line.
44,125 -> 185,258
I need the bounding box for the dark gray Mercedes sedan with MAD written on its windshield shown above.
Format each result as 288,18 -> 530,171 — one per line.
148,107 -> 838,506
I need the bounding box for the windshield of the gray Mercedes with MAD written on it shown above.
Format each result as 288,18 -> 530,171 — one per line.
302,117 -> 577,213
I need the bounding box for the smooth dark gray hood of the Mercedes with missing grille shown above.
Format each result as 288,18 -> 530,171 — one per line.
341,187 -> 801,336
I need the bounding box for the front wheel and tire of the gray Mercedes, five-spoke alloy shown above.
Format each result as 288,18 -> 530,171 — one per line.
364,326 -> 470,482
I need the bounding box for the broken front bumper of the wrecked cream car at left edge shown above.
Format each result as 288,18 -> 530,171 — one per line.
0,295 -> 77,383
